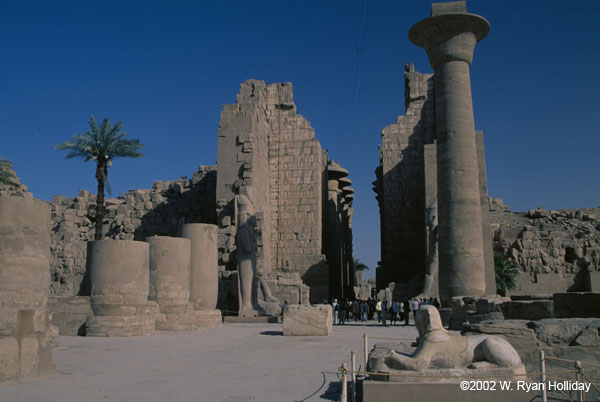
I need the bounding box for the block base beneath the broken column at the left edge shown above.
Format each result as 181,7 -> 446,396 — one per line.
0,308 -> 58,381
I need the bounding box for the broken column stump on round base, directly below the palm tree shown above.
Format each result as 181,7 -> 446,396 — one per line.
86,240 -> 158,336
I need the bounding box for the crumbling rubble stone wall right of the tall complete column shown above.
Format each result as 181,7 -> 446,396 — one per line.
490,204 -> 600,294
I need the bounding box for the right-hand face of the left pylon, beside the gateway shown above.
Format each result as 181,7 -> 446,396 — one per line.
267,83 -> 329,301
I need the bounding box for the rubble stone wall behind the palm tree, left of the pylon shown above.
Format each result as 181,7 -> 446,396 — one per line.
50,166 -> 216,295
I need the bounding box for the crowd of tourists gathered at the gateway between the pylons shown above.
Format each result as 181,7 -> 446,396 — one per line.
331,298 -> 440,327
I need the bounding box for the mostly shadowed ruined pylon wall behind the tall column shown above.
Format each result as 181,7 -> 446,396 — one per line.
377,65 -> 435,288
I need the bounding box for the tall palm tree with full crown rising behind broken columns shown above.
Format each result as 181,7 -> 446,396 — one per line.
54,116 -> 146,240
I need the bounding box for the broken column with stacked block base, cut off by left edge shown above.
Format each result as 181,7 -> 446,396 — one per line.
0,196 -> 58,381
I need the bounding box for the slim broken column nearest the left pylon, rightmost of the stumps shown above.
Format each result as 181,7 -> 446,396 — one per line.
179,223 -> 221,327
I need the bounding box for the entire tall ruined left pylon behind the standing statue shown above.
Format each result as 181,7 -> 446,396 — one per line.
217,80 -> 328,310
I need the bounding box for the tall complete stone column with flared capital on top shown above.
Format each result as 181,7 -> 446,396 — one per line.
408,1 -> 489,300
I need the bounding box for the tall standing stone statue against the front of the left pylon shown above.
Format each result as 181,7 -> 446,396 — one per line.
235,195 -> 262,317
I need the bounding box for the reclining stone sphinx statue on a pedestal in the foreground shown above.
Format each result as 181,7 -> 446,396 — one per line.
369,305 -> 525,375
